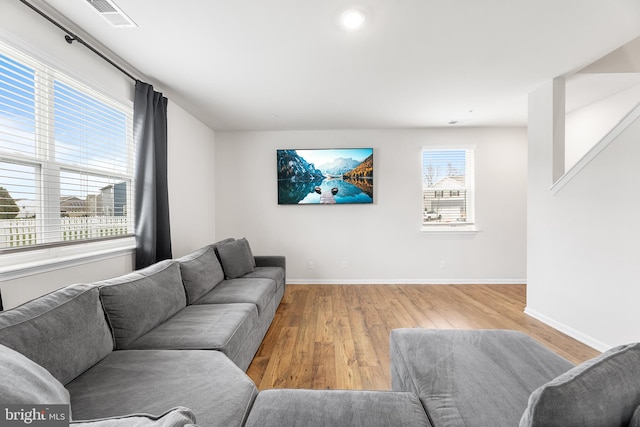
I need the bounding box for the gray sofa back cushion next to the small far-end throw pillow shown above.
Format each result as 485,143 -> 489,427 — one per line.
178,246 -> 224,304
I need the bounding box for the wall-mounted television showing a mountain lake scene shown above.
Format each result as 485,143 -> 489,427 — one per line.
277,148 -> 373,205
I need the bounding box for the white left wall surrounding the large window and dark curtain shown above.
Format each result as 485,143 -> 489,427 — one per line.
0,1 -> 215,309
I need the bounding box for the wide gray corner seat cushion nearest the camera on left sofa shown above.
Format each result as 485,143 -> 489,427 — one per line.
67,350 -> 257,427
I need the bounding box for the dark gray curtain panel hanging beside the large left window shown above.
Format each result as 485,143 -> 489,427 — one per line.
133,80 -> 172,269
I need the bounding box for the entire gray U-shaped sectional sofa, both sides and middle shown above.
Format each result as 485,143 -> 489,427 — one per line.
0,239 -> 640,427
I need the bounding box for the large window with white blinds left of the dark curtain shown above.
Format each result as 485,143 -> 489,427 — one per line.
0,44 -> 135,253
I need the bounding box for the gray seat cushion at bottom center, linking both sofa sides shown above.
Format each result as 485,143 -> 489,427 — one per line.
246,389 -> 431,427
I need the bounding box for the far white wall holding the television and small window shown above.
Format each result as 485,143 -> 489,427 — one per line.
215,128 -> 527,283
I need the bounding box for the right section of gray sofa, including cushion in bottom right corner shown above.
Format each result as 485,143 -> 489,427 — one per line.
390,329 -> 640,427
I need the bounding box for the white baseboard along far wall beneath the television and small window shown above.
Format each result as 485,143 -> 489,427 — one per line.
287,277 -> 527,285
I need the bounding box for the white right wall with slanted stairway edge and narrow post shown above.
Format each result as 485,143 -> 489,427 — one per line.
526,83 -> 640,350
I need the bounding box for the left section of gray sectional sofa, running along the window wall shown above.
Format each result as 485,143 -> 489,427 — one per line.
0,239 -> 286,427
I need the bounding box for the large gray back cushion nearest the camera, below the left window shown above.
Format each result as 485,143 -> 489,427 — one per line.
0,285 -> 113,384
